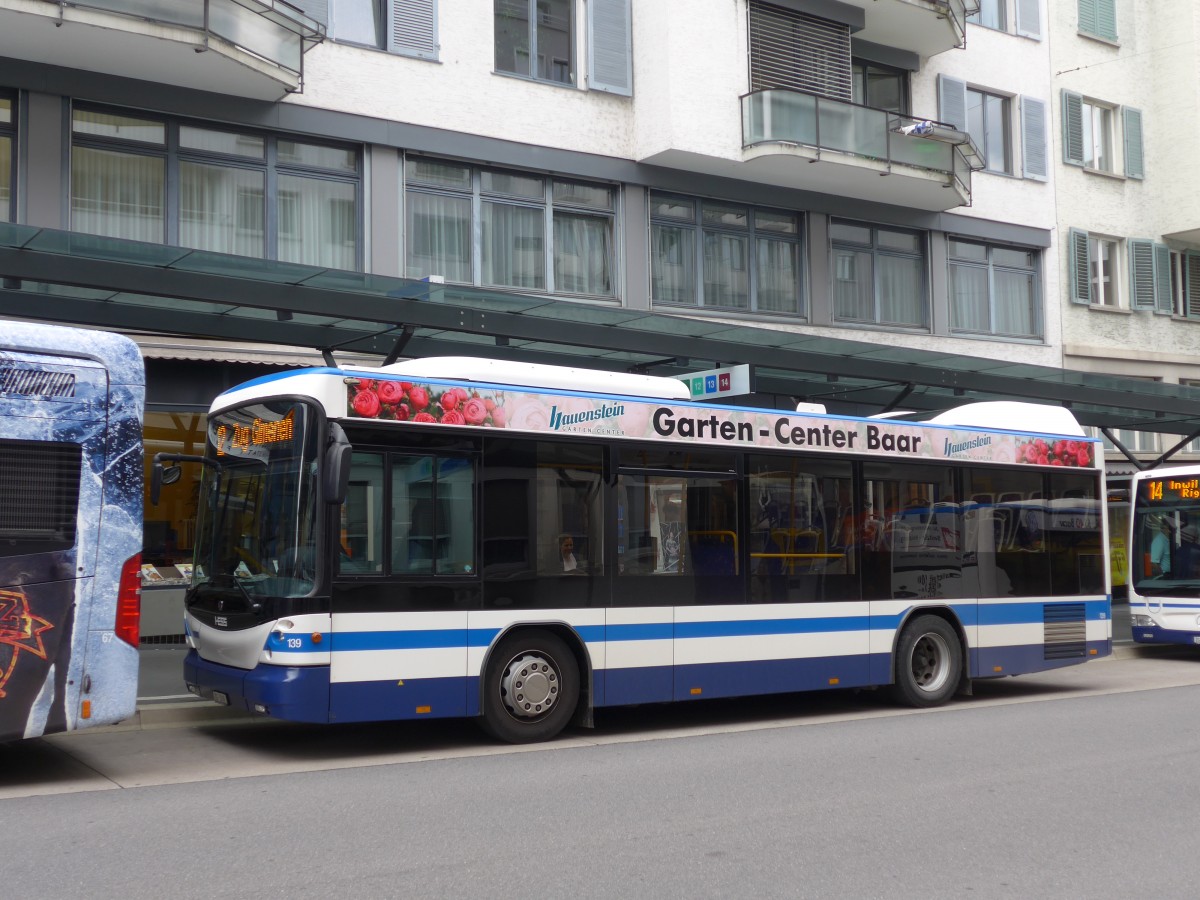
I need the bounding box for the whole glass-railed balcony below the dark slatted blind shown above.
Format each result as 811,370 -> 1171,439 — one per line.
742,88 -> 983,211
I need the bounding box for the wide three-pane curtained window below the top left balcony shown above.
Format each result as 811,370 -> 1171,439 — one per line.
71,108 -> 361,270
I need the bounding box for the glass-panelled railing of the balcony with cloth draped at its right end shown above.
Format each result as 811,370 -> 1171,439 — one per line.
742,88 -> 983,198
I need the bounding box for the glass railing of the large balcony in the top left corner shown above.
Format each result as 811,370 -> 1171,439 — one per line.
47,0 -> 325,79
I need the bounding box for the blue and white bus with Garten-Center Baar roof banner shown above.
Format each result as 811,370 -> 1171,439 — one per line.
152,358 -> 1112,742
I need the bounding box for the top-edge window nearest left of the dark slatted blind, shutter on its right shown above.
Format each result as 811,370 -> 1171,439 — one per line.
496,0 -> 575,84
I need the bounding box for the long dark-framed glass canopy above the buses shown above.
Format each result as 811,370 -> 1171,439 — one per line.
0,223 -> 1200,452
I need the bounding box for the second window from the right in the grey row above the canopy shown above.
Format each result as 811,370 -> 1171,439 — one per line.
829,220 -> 929,328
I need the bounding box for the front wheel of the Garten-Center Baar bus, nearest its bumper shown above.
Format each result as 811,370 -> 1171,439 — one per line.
481,629 -> 580,744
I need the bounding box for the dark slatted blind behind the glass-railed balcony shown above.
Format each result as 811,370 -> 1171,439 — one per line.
750,0 -> 854,102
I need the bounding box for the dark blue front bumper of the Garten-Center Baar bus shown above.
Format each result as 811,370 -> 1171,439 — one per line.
184,649 -> 330,722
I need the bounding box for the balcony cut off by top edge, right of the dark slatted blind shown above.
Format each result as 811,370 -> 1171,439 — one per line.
841,0 -> 979,58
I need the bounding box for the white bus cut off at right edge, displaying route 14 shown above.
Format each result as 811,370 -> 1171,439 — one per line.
1129,466 -> 1200,644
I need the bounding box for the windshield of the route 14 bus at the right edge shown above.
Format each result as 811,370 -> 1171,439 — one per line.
1130,476 -> 1200,595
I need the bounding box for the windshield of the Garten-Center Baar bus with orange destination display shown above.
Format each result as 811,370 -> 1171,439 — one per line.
192,400 -> 318,605
